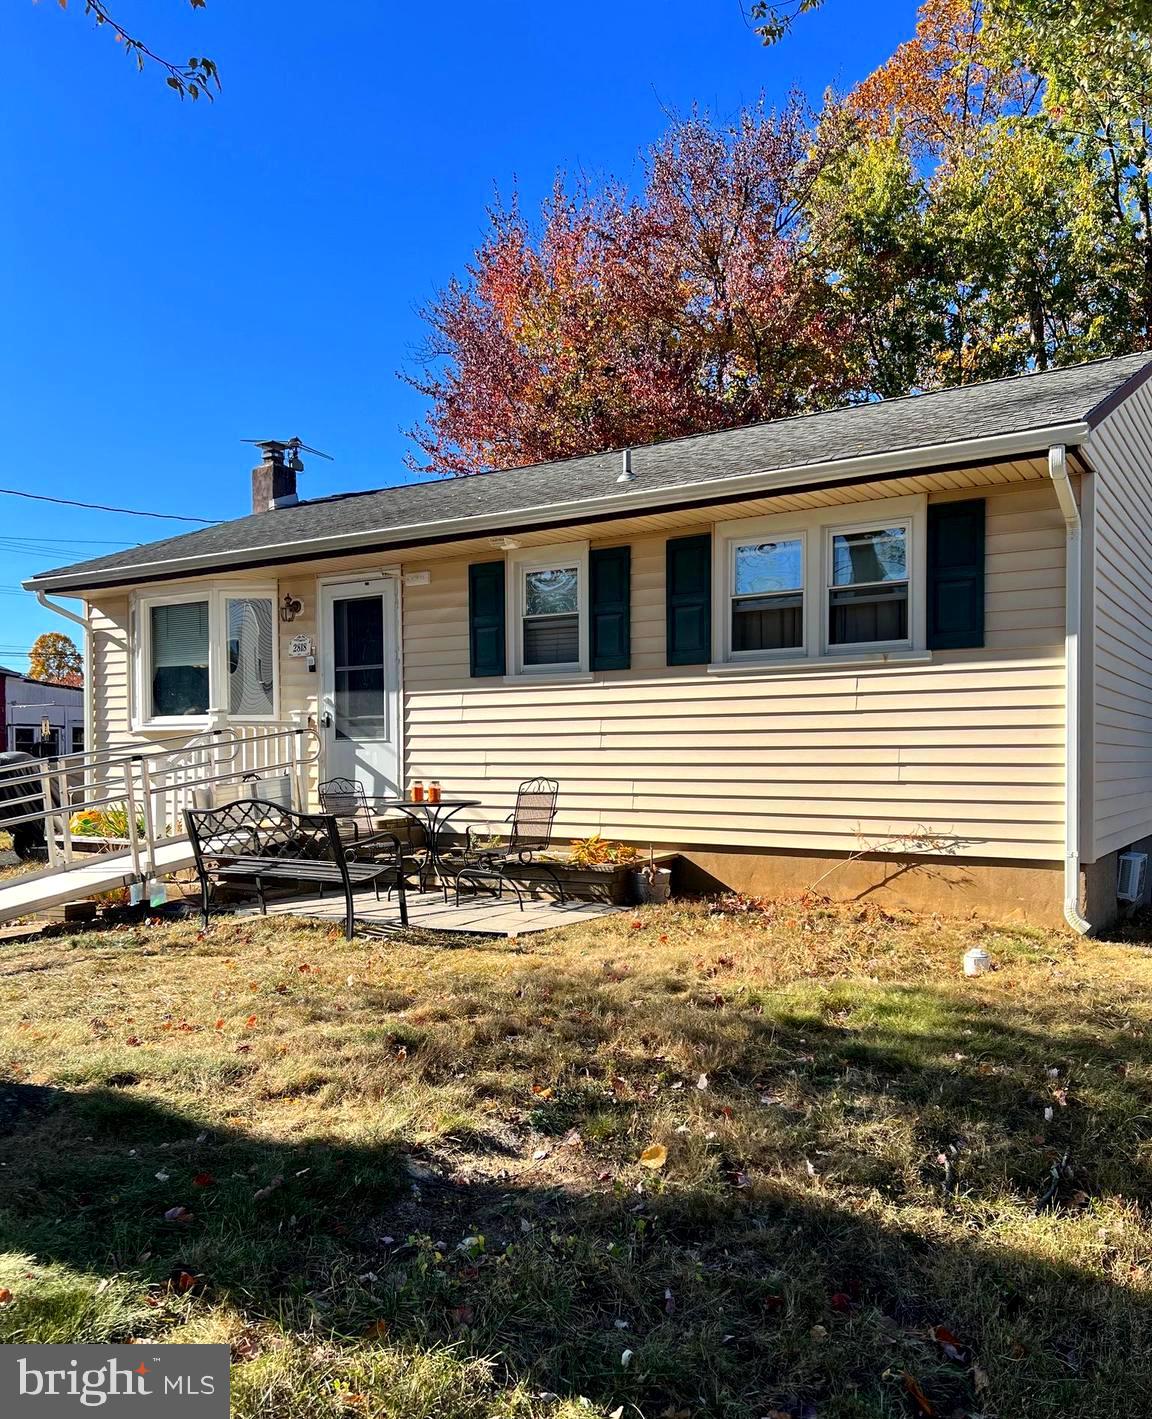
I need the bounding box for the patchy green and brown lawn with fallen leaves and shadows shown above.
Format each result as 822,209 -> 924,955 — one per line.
0,904 -> 1152,1419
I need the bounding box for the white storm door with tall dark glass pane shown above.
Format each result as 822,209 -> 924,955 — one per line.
319,578 -> 400,797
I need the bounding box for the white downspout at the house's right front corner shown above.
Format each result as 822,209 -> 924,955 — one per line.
1048,444 -> 1092,937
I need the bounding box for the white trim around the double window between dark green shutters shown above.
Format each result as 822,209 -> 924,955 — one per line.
708,494 -> 928,673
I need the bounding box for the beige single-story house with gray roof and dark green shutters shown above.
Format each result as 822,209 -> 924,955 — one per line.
26,355 -> 1152,929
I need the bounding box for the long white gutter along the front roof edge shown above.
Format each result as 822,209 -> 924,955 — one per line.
23,420 -> 1090,590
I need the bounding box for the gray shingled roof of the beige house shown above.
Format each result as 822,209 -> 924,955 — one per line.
26,353 -> 1152,590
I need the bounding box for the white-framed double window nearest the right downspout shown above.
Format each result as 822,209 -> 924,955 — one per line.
714,495 -> 926,664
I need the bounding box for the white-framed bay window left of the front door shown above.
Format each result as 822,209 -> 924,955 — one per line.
133,586 -> 277,725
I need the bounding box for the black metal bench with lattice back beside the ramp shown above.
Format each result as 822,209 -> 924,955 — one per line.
184,799 -> 409,941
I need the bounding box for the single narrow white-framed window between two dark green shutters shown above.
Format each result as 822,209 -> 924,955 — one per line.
508,542 -> 587,675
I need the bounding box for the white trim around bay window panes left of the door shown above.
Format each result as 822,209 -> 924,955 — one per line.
132,582 -> 279,731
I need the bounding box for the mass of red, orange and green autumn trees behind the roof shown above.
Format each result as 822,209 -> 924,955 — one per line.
407,0 -> 1152,474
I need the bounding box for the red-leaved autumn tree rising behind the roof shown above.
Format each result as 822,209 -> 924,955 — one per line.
409,101 -> 850,474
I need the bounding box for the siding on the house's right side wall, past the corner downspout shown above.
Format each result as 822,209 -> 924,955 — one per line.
1088,385 -> 1152,860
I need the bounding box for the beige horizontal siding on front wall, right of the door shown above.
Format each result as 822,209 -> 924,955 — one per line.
403,484 -> 1064,860
